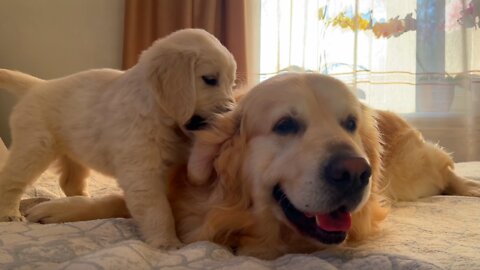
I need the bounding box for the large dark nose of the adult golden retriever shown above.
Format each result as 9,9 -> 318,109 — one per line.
324,156 -> 372,192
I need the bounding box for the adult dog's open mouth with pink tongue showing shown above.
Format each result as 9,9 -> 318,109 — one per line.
273,185 -> 352,244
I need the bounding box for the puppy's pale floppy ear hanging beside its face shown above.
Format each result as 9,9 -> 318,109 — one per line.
141,44 -> 197,125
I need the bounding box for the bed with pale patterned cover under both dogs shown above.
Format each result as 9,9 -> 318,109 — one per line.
0,141 -> 480,269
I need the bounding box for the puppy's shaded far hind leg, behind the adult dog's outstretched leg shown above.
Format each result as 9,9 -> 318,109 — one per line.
59,156 -> 90,196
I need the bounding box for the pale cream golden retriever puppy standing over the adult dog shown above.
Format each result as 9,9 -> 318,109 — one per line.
0,29 -> 236,247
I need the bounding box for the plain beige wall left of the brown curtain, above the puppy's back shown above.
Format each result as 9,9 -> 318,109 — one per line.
0,0 -> 124,145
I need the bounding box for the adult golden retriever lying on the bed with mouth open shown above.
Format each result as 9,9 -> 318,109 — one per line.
23,73 -> 480,258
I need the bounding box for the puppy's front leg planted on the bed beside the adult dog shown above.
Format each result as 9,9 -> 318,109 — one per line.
118,171 -> 183,248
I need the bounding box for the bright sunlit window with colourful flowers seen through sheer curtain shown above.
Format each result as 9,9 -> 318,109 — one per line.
260,0 -> 478,113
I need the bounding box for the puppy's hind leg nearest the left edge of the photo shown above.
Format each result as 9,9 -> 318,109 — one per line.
0,134 -> 55,221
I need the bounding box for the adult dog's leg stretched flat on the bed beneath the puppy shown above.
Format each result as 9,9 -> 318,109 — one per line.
25,194 -> 130,223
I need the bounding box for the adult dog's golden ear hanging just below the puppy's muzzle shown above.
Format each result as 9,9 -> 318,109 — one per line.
188,110 -> 241,185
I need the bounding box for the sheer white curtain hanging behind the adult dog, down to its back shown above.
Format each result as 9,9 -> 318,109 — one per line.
259,0 -> 480,161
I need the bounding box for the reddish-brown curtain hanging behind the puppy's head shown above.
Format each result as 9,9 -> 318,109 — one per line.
123,0 -> 247,83
